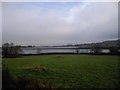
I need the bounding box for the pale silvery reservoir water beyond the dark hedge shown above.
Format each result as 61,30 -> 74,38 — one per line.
21,48 -> 110,54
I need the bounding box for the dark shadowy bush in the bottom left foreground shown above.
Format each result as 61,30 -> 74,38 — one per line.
2,67 -> 59,90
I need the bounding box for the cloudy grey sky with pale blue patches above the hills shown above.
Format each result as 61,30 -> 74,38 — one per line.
2,2 -> 118,45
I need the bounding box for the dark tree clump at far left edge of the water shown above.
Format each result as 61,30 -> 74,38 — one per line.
2,43 -> 21,57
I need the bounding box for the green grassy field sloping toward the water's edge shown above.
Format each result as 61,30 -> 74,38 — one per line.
3,55 -> 118,88
